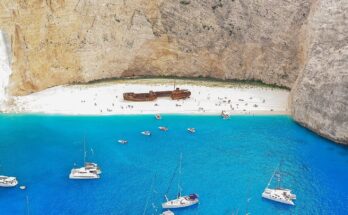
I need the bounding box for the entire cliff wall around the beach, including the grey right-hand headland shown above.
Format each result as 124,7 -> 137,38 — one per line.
0,0 -> 348,143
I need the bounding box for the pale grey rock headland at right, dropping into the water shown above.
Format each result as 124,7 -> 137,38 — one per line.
292,0 -> 348,144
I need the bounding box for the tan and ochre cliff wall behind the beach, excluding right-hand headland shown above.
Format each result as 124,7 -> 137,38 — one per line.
0,0 -> 310,95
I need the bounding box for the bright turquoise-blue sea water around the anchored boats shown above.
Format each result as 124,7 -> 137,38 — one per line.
0,115 -> 348,215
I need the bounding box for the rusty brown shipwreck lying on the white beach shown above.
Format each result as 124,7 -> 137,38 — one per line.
123,88 -> 191,102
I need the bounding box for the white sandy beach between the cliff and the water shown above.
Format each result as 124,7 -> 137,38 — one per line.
2,82 -> 289,115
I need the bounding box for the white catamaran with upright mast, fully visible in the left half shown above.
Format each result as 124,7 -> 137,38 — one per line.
69,139 -> 101,179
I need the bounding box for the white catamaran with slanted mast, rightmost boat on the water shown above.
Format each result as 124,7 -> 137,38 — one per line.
262,166 -> 296,205
